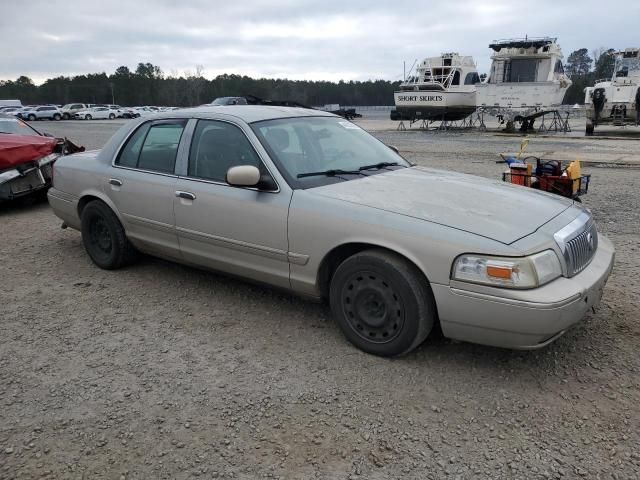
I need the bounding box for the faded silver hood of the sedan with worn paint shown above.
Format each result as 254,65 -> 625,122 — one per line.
308,167 -> 573,244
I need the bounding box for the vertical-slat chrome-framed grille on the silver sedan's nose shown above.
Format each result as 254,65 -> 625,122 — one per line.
554,211 -> 598,277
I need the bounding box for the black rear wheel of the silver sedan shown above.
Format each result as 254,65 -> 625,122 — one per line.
80,200 -> 136,270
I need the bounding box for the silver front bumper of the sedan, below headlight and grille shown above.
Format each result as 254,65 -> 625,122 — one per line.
432,235 -> 615,349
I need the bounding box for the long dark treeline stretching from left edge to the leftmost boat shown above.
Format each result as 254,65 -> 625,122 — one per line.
0,63 -> 400,107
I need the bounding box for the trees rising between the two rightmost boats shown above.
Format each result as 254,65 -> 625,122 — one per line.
564,48 -> 615,105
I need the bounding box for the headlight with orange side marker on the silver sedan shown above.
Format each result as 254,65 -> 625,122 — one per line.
451,250 -> 562,288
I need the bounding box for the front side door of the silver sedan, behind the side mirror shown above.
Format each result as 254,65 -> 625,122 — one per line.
174,120 -> 291,288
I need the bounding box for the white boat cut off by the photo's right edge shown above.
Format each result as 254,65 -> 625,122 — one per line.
584,48 -> 640,135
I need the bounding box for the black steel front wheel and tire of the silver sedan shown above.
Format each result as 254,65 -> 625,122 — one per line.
329,250 -> 437,357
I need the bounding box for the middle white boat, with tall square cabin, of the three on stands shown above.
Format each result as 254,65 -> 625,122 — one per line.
476,37 -> 571,112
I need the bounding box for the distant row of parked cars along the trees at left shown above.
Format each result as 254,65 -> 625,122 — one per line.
0,103 -> 178,121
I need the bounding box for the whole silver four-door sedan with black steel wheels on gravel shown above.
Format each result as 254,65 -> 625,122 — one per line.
49,106 -> 614,356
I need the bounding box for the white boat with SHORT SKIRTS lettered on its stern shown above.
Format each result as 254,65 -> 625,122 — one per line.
391,53 -> 480,121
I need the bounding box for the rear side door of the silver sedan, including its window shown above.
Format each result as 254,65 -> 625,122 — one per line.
105,119 -> 187,258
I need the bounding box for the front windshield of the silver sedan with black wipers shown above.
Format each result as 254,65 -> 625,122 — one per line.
251,117 -> 411,188
